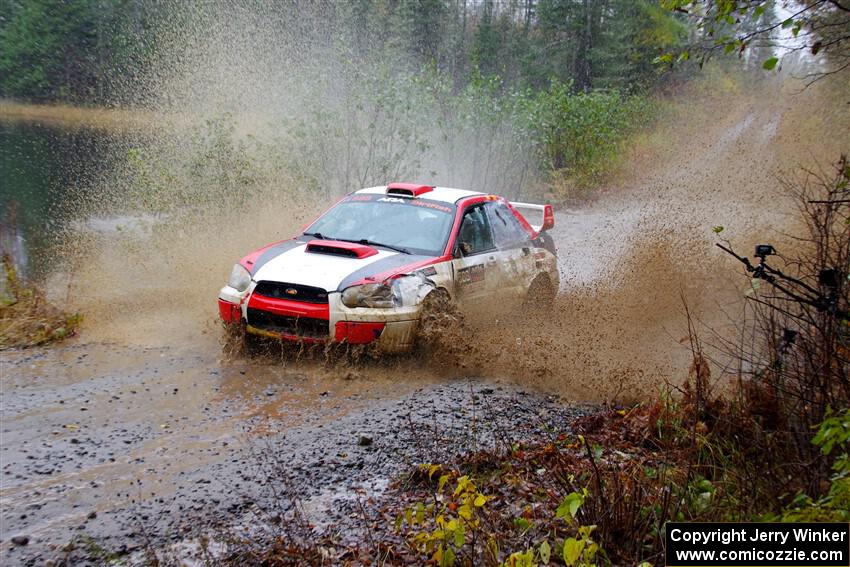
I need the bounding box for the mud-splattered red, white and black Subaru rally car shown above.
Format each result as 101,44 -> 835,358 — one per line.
218,183 -> 559,352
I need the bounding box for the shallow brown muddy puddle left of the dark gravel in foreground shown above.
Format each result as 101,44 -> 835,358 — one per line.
0,343 -> 438,560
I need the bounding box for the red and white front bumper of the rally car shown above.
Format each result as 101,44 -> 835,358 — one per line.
218,285 -> 420,353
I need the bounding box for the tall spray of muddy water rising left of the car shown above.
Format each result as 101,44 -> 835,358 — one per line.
36,0 -> 528,364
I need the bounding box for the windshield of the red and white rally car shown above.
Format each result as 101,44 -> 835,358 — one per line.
305,194 -> 455,256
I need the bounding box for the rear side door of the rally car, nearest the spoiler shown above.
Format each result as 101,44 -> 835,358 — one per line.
484,201 -> 534,302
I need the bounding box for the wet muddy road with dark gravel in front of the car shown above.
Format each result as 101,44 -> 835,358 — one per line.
0,344 -> 579,565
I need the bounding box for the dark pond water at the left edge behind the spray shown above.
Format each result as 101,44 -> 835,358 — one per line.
0,120 -> 115,278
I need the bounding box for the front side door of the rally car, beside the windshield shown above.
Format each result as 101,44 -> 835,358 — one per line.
452,203 -> 499,306
